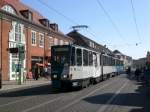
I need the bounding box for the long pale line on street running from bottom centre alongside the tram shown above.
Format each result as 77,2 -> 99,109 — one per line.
56,81 -> 114,112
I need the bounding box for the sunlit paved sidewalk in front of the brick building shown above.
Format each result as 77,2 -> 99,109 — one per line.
0,78 -> 51,94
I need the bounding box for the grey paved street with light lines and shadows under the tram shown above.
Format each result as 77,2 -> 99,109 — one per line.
0,74 -> 150,112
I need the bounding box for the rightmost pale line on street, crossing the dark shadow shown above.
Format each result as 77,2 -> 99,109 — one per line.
97,80 -> 129,112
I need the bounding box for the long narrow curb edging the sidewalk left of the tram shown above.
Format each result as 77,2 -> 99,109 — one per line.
0,82 -> 51,95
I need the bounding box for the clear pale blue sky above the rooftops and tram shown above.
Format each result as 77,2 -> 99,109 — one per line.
21,0 -> 150,59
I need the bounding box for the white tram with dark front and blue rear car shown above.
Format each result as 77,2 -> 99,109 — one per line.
51,45 -> 123,88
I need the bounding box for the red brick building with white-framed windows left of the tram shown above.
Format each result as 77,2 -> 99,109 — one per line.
0,0 -> 72,80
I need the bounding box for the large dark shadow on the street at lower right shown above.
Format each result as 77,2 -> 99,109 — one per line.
83,73 -> 150,112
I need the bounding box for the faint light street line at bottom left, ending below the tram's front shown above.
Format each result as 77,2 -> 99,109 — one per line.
22,96 -> 63,112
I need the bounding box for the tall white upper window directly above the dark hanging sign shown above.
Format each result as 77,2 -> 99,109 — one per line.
15,23 -> 21,42
